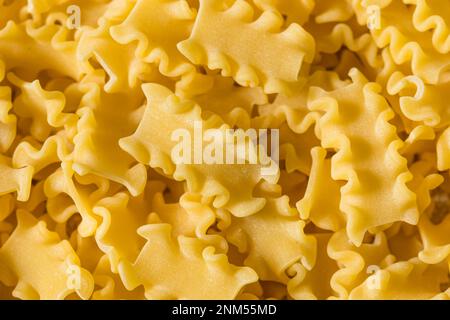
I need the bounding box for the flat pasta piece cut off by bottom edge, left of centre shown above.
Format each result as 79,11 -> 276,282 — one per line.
119,224 -> 258,299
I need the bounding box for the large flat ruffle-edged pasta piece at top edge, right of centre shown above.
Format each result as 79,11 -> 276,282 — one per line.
178,0 -> 314,93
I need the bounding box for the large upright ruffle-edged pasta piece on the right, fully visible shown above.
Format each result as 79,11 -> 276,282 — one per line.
309,69 -> 419,245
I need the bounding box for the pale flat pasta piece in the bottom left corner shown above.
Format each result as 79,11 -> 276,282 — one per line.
0,211 -> 94,299
